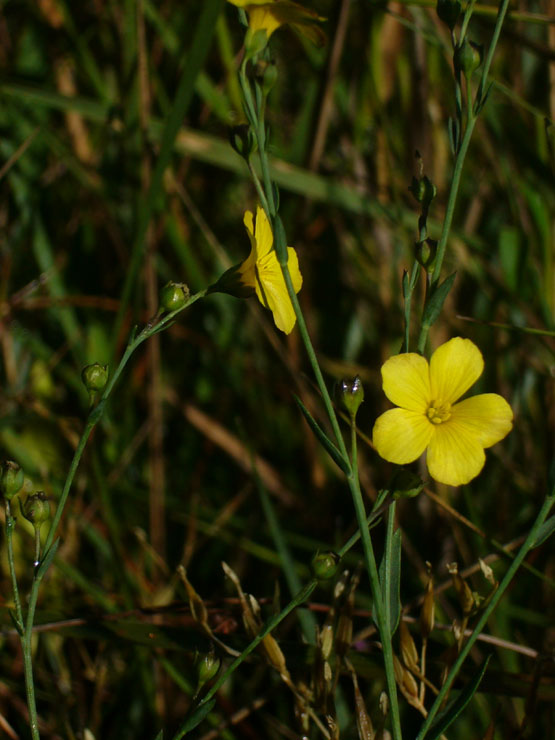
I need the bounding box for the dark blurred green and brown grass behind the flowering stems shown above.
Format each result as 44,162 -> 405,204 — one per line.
0,0 -> 555,740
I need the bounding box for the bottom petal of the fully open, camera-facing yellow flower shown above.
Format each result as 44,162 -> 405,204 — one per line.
426,417 -> 486,486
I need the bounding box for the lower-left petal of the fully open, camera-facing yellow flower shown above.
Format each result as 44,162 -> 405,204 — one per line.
372,410 -> 435,465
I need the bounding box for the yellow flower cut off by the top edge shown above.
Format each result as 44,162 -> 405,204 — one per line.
228,0 -> 326,46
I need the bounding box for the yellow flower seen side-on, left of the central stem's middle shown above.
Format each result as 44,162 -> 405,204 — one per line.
238,206 -> 303,334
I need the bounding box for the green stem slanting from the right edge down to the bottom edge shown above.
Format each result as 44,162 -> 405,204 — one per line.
416,488 -> 555,740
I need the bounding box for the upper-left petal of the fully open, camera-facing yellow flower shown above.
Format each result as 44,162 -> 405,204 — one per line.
382,352 -> 431,413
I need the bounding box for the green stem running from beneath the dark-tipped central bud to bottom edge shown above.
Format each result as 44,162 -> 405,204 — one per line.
347,419 -> 403,740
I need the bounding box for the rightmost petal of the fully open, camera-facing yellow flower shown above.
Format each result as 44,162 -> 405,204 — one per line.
448,393 -> 513,447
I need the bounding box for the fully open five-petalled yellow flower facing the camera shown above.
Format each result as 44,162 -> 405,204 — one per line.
373,337 -> 513,486
